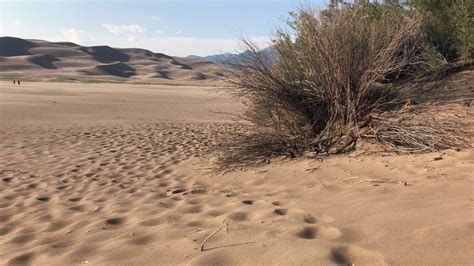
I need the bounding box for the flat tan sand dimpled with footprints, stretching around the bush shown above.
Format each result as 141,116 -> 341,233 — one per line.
0,82 -> 474,265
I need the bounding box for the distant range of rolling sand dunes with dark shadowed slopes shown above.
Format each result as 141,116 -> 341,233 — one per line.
0,37 -> 223,83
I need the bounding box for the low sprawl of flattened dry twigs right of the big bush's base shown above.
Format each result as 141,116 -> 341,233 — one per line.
363,104 -> 473,153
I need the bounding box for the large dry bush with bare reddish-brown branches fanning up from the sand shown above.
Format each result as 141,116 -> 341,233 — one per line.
219,5 -> 474,169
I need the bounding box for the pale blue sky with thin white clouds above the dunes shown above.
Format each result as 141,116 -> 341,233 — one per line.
0,0 -> 326,56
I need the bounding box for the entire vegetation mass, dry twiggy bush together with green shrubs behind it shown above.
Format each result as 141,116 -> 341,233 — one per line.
217,0 -> 474,169
